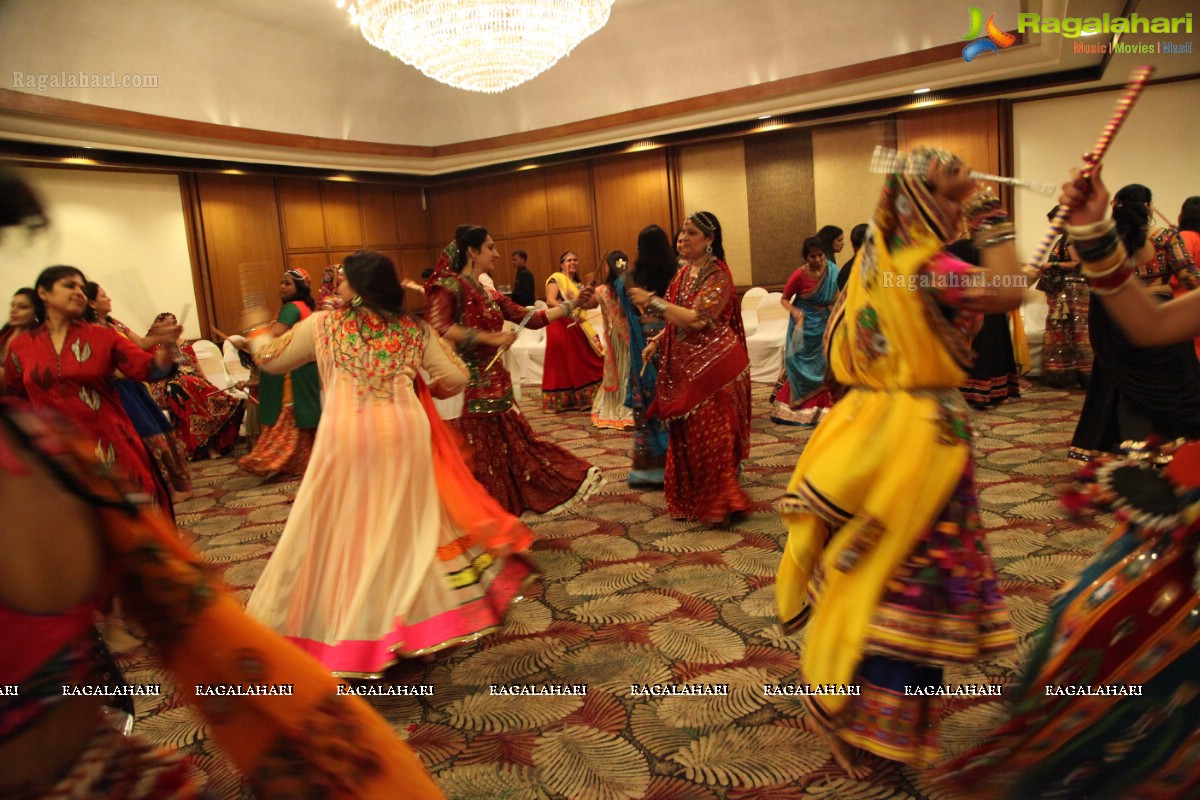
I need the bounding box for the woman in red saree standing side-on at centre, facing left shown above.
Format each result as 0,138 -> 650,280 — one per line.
629,211 -> 750,524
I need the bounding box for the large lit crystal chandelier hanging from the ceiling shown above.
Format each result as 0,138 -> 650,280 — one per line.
338,0 -> 613,94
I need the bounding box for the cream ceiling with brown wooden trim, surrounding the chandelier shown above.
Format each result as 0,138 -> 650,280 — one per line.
0,0 -> 1200,175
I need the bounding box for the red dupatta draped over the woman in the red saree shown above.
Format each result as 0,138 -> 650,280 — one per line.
647,258 -> 750,420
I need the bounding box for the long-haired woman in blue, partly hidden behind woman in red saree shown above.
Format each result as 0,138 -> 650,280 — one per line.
617,225 -> 679,487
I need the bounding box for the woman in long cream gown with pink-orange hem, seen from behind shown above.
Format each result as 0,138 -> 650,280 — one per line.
246,252 -> 533,678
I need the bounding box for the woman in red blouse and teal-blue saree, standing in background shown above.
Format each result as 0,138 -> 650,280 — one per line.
770,236 -> 838,425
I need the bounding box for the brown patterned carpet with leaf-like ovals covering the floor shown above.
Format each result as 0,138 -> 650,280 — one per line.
112,385 -> 1106,800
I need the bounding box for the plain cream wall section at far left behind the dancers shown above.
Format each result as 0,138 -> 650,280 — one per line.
0,169 -> 200,337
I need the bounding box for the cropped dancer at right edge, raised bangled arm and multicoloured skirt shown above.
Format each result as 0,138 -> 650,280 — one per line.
941,167 -> 1200,800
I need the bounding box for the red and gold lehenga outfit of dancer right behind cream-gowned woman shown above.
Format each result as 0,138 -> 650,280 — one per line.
426,259 -> 593,515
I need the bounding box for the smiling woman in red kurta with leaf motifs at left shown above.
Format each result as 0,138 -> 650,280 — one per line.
4,266 -> 180,513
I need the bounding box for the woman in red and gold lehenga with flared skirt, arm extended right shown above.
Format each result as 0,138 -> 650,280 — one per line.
425,225 -> 593,515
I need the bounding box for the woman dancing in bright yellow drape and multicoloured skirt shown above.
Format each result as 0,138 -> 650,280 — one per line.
775,150 -> 1021,777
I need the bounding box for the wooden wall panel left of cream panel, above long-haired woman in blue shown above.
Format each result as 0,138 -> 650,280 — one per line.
592,149 -> 671,258
